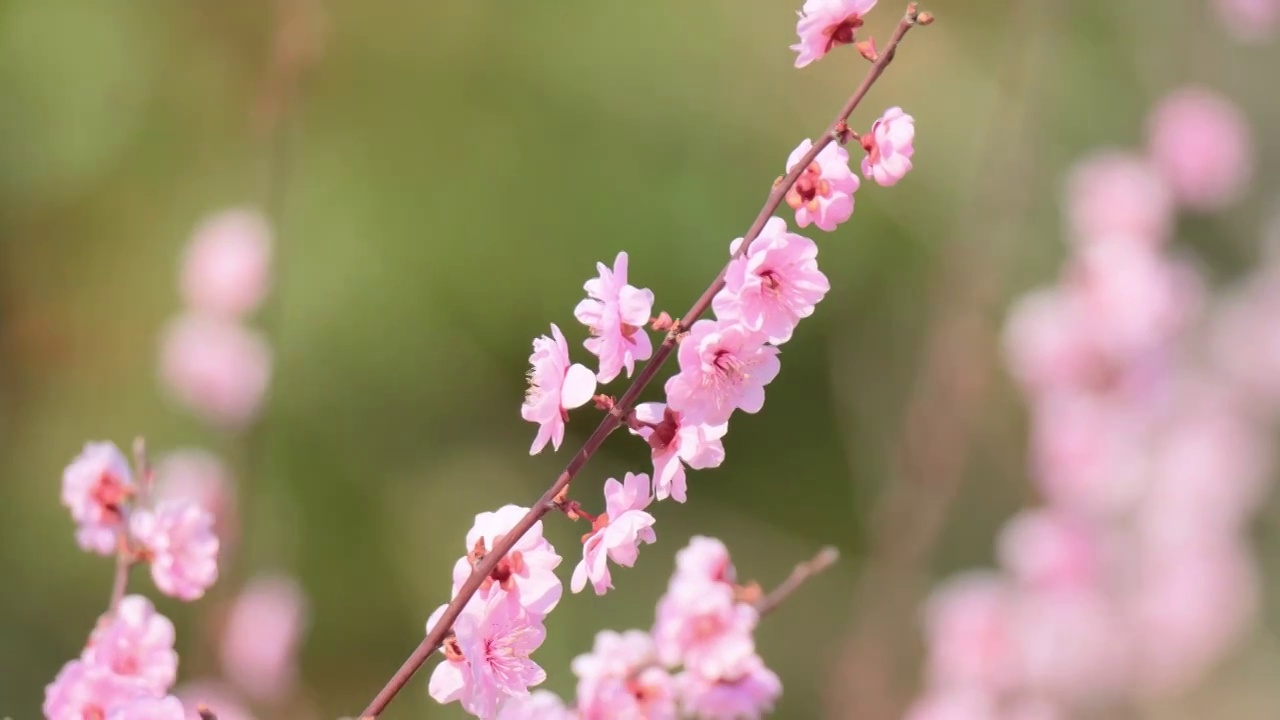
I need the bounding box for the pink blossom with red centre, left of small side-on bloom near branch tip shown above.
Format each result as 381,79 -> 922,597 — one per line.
787,138 -> 860,232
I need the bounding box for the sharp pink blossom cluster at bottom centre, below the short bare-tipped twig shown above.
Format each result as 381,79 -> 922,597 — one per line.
486,537 -> 782,720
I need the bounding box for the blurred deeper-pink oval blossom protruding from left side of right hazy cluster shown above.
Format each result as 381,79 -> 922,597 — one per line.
997,509 -> 1103,591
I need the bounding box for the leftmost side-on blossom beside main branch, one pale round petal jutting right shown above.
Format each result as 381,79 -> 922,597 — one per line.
520,323 -> 595,455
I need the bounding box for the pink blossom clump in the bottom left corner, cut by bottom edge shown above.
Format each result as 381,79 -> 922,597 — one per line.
44,594 -> 186,720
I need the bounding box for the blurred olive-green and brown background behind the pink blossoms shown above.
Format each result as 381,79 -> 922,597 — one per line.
0,0 -> 1280,719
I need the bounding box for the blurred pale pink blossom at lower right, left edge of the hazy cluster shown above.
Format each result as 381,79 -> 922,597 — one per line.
924,571 -> 1019,692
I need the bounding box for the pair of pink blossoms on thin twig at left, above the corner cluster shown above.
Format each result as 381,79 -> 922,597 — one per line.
63,442 -> 218,600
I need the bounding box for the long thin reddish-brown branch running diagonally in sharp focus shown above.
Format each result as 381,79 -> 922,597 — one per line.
361,8 -> 916,720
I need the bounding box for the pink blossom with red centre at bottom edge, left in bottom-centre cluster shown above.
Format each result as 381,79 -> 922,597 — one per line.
572,630 -> 676,720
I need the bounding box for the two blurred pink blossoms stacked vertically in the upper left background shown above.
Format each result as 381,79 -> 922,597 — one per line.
160,210 -> 271,428
